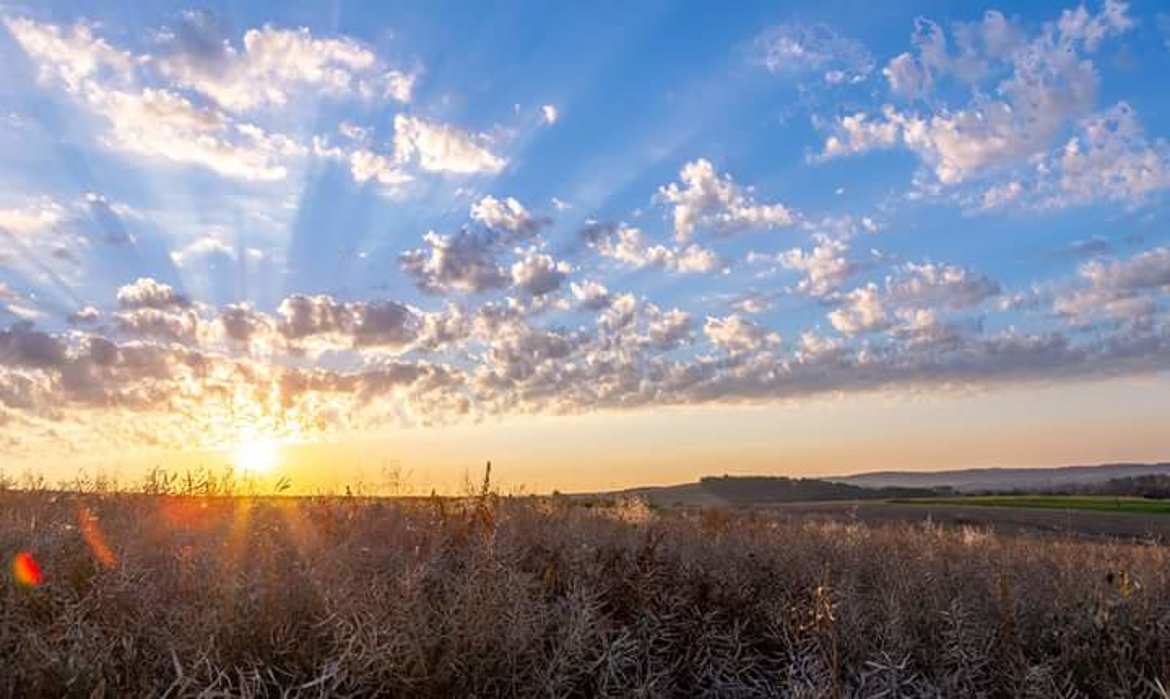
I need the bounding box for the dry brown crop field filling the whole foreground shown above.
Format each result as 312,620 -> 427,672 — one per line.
0,492 -> 1170,697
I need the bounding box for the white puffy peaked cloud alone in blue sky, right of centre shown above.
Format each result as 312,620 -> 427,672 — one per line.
655,158 -> 796,242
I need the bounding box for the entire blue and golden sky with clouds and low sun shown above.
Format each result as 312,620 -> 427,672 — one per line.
0,0 -> 1170,492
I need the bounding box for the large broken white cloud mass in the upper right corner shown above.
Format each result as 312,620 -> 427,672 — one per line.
813,0 -> 1141,204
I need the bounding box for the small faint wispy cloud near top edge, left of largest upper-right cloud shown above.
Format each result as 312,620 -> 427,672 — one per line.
750,23 -> 874,84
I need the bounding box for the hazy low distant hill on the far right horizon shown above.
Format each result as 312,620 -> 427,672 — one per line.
825,462 -> 1170,493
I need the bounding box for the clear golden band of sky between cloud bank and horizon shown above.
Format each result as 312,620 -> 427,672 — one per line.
8,376 -> 1170,494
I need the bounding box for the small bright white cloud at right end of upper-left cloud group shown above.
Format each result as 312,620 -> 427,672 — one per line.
394,114 -> 508,174
